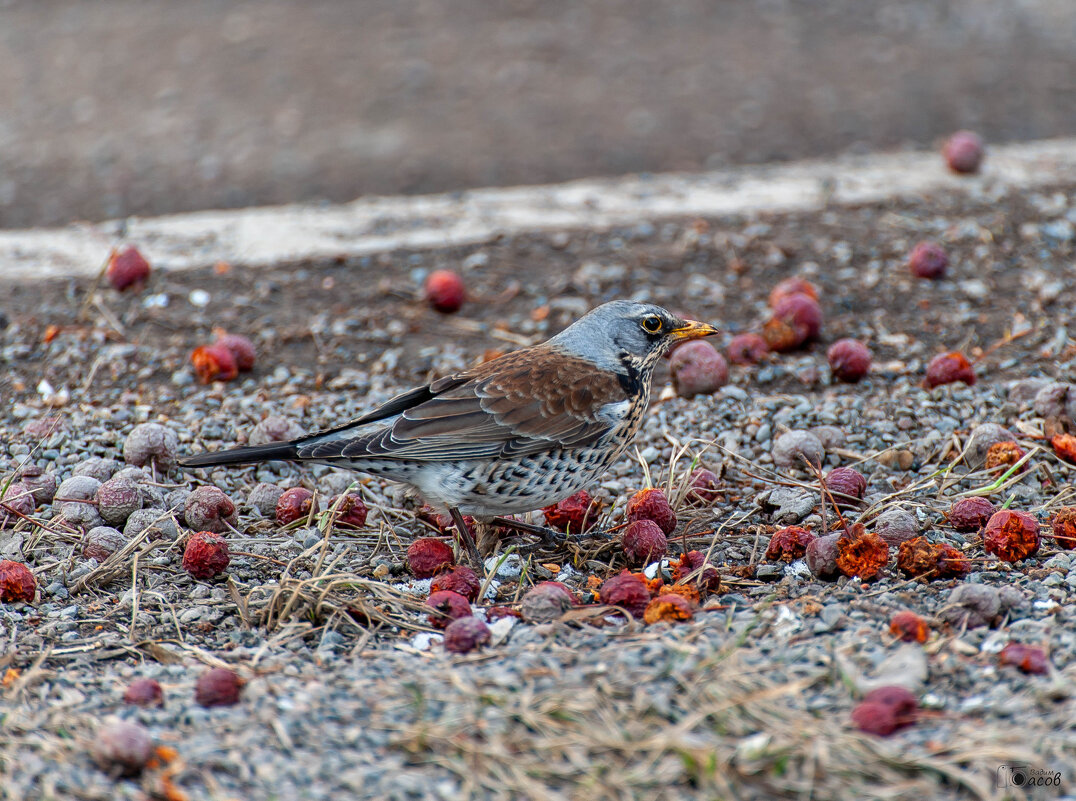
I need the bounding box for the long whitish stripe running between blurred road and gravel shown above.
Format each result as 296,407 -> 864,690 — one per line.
0,139 -> 1076,280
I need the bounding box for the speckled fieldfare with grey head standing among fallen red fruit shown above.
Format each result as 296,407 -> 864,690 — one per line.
180,300 -> 718,560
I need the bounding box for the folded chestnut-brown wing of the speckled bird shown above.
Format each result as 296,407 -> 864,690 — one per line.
300,347 -> 627,462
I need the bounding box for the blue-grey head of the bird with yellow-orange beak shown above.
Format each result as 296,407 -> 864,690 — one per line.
549,300 -> 718,377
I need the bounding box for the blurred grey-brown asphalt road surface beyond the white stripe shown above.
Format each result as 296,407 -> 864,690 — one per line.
0,0 -> 1076,227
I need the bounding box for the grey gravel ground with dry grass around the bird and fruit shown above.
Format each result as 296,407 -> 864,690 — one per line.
0,178 -> 1076,799
